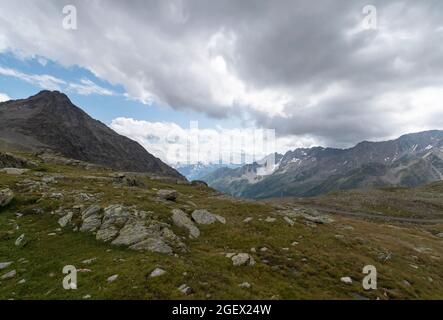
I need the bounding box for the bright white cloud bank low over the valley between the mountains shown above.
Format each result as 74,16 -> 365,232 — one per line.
110,118 -> 316,164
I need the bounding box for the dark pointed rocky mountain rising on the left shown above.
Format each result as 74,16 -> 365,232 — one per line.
0,91 -> 184,180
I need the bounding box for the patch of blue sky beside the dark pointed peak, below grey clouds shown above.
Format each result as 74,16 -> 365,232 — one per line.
0,52 -> 240,128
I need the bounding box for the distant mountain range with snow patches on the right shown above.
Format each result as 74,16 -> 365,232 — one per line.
202,130 -> 443,199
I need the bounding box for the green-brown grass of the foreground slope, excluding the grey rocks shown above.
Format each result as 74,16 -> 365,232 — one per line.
0,151 -> 443,299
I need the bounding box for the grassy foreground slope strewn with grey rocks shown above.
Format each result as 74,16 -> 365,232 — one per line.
0,153 -> 443,300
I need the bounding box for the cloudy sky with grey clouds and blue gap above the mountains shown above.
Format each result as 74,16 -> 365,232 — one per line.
0,0 -> 443,162
